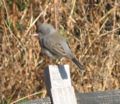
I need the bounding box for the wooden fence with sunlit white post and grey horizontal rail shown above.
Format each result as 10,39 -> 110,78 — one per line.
23,65 -> 120,104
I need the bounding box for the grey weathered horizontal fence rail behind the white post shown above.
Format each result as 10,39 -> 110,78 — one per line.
23,90 -> 120,104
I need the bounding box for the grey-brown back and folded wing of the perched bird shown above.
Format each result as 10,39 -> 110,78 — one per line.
43,34 -> 71,57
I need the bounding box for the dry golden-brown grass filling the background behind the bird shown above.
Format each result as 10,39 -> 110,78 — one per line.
0,0 -> 120,103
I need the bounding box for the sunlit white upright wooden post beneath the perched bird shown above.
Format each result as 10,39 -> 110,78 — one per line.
45,65 -> 77,104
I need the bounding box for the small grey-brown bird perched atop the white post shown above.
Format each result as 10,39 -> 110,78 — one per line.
34,22 -> 84,71
